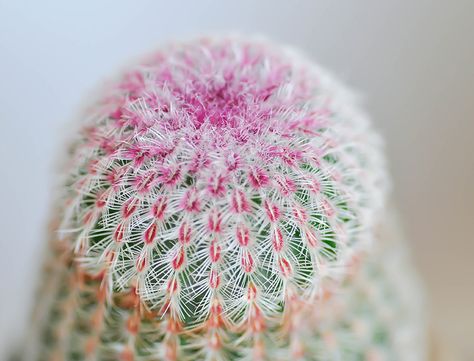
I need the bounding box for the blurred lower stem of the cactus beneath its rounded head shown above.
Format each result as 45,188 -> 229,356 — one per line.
27,210 -> 425,361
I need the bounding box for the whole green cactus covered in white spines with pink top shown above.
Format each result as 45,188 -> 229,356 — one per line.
22,38 -> 421,361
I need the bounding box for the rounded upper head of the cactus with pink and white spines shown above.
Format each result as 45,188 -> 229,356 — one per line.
32,39 -> 392,360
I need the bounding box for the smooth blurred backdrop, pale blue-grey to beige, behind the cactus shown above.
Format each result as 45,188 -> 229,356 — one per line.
0,0 -> 474,361
